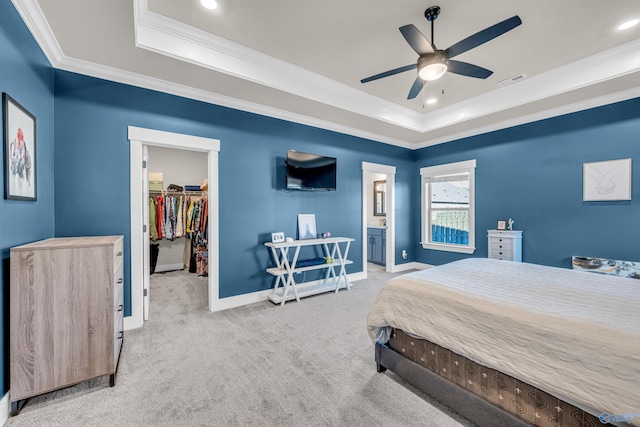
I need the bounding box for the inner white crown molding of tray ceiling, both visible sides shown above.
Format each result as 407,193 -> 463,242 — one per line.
134,0 -> 640,137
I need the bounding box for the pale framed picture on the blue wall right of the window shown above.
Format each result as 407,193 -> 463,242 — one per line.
582,159 -> 631,202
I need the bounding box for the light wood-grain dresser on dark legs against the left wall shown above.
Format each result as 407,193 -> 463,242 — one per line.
10,236 -> 124,415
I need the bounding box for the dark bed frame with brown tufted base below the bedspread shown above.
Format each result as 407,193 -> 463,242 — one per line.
375,329 -> 602,427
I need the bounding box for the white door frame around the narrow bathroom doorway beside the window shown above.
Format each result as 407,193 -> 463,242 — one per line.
362,162 -> 396,277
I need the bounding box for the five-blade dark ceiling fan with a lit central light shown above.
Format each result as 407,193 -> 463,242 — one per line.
360,6 -> 522,99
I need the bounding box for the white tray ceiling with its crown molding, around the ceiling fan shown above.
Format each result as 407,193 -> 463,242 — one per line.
12,0 -> 640,149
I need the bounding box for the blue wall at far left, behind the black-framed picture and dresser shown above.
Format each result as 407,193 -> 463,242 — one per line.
0,0 -> 54,395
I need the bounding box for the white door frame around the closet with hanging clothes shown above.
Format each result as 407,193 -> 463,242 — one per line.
124,126 -> 220,330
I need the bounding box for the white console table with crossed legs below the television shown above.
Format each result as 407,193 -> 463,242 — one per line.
264,237 -> 354,305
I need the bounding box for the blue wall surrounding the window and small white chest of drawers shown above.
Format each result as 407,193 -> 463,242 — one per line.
413,99 -> 640,268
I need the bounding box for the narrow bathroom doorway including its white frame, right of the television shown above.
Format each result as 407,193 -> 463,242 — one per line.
362,162 -> 396,274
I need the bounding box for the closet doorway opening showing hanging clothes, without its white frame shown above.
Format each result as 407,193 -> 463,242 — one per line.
143,145 -> 209,320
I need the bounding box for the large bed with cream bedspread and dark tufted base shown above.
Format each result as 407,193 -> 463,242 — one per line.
368,258 -> 640,426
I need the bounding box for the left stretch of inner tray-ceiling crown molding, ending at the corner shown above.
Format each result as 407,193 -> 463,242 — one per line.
134,0 -> 423,132
